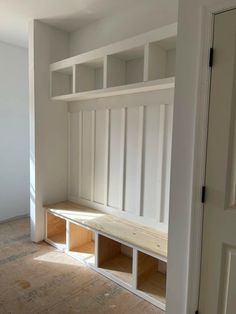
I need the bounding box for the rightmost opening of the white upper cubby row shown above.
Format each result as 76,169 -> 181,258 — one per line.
148,37 -> 176,81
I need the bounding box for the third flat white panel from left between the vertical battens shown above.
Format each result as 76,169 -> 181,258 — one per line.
93,110 -> 106,204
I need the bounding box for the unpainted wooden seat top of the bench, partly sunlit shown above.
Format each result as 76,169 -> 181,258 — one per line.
44,201 -> 167,258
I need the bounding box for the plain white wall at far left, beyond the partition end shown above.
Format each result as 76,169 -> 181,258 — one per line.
0,42 -> 29,221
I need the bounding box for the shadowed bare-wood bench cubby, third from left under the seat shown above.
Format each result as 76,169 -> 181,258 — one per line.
98,235 -> 133,285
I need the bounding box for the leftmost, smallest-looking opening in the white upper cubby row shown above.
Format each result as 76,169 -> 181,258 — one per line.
51,66 -> 73,97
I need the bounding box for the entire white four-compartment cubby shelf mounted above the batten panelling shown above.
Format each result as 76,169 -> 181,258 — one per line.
50,24 -> 177,101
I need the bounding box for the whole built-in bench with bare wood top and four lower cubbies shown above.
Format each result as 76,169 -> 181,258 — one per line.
44,201 -> 167,310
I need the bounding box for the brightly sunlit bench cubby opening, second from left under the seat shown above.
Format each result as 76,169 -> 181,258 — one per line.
68,222 -> 95,265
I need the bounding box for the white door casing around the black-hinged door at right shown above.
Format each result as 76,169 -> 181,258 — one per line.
187,0 -> 236,313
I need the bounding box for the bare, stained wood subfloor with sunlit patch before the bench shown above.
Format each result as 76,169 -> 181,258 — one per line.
0,219 -> 164,314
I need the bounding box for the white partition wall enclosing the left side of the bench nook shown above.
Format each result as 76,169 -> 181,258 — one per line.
29,21 -> 68,242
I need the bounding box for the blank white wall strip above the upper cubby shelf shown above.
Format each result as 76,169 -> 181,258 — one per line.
70,0 -> 178,56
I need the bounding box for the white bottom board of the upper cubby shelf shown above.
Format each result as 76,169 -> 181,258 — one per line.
51,77 -> 175,101
